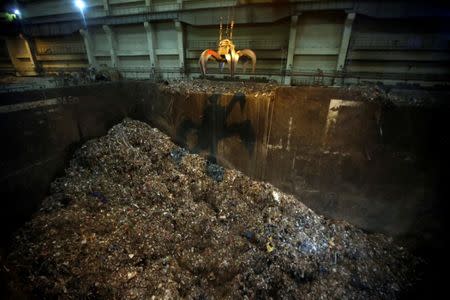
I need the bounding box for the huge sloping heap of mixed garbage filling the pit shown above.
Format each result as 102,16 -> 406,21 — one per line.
7,120 -> 416,299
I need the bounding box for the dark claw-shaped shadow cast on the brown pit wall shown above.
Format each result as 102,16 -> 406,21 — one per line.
176,93 -> 256,163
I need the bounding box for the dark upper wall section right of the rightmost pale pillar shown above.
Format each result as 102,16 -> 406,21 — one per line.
347,16 -> 450,82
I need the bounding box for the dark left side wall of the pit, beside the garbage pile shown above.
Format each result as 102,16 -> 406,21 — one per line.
0,82 -> 148,241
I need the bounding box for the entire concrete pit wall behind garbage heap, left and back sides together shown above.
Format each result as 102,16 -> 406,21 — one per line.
0,82 -> 449,251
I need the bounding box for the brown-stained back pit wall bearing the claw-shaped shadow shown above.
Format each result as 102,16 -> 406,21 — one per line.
145,87 -> 446,244
